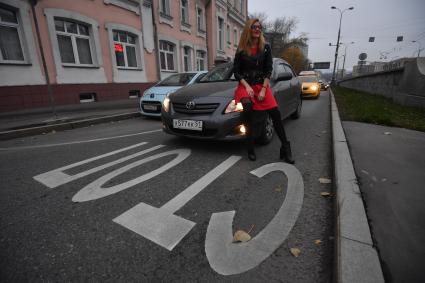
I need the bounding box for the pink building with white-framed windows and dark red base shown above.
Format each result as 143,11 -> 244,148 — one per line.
0,0 -> 247,111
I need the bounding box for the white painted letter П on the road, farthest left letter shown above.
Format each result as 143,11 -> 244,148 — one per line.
33,142 -> 165,189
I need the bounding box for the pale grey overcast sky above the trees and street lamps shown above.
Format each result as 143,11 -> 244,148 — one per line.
248,0 -> 425,72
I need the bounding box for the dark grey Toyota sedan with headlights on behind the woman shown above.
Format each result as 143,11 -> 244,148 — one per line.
161,58 -> 302,144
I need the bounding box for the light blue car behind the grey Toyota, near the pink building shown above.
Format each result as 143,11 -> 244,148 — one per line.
139,71 -> 207,117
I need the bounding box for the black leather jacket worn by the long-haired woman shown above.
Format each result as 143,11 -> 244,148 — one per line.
233,43 -> 273,85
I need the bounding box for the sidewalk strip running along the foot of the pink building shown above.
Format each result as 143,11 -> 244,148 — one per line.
0,98 -> 140,140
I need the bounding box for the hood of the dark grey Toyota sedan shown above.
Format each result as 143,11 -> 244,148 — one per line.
170,81 -> 238,99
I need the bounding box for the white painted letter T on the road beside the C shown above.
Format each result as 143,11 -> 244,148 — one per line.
113,156 -> 241,251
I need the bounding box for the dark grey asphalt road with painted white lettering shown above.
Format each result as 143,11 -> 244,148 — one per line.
0,92 -> 334,282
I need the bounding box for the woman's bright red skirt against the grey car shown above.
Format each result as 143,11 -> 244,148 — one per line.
234,84 -> 277,110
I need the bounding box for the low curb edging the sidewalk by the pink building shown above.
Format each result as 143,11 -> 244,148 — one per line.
0,112 -> 140,140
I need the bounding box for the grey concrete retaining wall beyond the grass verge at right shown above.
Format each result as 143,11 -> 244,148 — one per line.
339,57 -> 425,108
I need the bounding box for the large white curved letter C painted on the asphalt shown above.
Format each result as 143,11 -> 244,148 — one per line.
205,163 -> 304,275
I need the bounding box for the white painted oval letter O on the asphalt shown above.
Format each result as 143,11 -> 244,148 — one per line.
72,149 -> 190,202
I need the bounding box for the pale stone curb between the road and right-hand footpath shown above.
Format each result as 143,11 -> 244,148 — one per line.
330,90 -> 385,283
